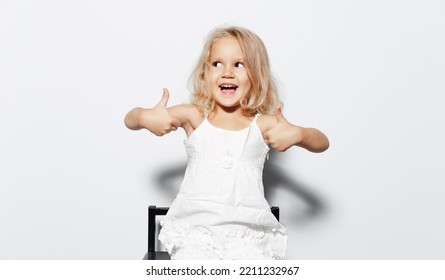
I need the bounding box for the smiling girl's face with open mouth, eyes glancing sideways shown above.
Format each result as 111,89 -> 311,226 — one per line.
209,37 -> 251,109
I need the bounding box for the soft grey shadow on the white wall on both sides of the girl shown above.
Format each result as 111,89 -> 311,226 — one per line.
149,149 -> 327,225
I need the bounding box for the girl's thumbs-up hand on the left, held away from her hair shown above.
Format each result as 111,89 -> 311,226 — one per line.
139,88 -> 181,136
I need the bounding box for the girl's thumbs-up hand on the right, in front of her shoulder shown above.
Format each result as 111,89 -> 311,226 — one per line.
263,106 -> 303,152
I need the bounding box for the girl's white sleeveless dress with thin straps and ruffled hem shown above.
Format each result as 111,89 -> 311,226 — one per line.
159,115 -> 287,259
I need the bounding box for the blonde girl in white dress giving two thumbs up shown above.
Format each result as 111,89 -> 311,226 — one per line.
125,27 -> 329,259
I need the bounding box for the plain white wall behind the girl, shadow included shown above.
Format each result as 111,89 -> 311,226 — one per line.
0,0 -> 445,259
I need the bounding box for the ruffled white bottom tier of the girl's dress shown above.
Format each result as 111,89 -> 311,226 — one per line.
159,221 -> 287,260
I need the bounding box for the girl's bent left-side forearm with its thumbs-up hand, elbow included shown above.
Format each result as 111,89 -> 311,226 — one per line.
124,88 -> 187,136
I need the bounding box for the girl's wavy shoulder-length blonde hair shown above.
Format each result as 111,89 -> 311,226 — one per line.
189,26 -> 281,116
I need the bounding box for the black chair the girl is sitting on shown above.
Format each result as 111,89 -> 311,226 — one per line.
144,205 -> 280,260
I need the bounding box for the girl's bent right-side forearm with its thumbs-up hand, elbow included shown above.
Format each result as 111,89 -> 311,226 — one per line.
263,107 -> 329,153
